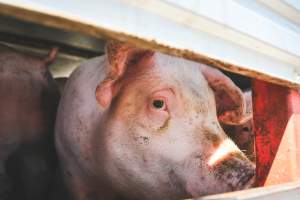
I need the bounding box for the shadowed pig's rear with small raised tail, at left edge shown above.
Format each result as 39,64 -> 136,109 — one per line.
0,45 -> 59,200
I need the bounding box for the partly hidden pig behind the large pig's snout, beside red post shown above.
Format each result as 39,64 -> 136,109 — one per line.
222,90 -> 255,162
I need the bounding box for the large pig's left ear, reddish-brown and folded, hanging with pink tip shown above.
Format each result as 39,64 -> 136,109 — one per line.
96,41 -> 153,108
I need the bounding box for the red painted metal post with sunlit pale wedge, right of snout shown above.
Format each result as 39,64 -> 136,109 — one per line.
252,80 -> 300,186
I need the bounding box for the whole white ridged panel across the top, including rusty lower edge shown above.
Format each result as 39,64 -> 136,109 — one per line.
0,0 -> 300,87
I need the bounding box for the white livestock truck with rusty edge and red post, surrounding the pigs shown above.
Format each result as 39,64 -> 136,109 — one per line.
0,0 -> 300,200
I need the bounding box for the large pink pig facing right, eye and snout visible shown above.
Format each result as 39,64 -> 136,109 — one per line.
55,42 -> 254,200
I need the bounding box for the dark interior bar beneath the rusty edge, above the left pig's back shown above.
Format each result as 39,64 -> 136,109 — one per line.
0,15 -> 105,57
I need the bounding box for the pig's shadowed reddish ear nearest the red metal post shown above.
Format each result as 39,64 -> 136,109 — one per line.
201,64 -> 246,124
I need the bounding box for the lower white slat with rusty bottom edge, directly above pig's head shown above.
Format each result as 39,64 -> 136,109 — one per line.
0,0 -> 300,87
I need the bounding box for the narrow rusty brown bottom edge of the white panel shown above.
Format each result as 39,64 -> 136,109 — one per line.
0,3 -> 300,88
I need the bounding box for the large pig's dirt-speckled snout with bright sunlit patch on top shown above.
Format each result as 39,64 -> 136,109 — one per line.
208,139 -> 255,191
